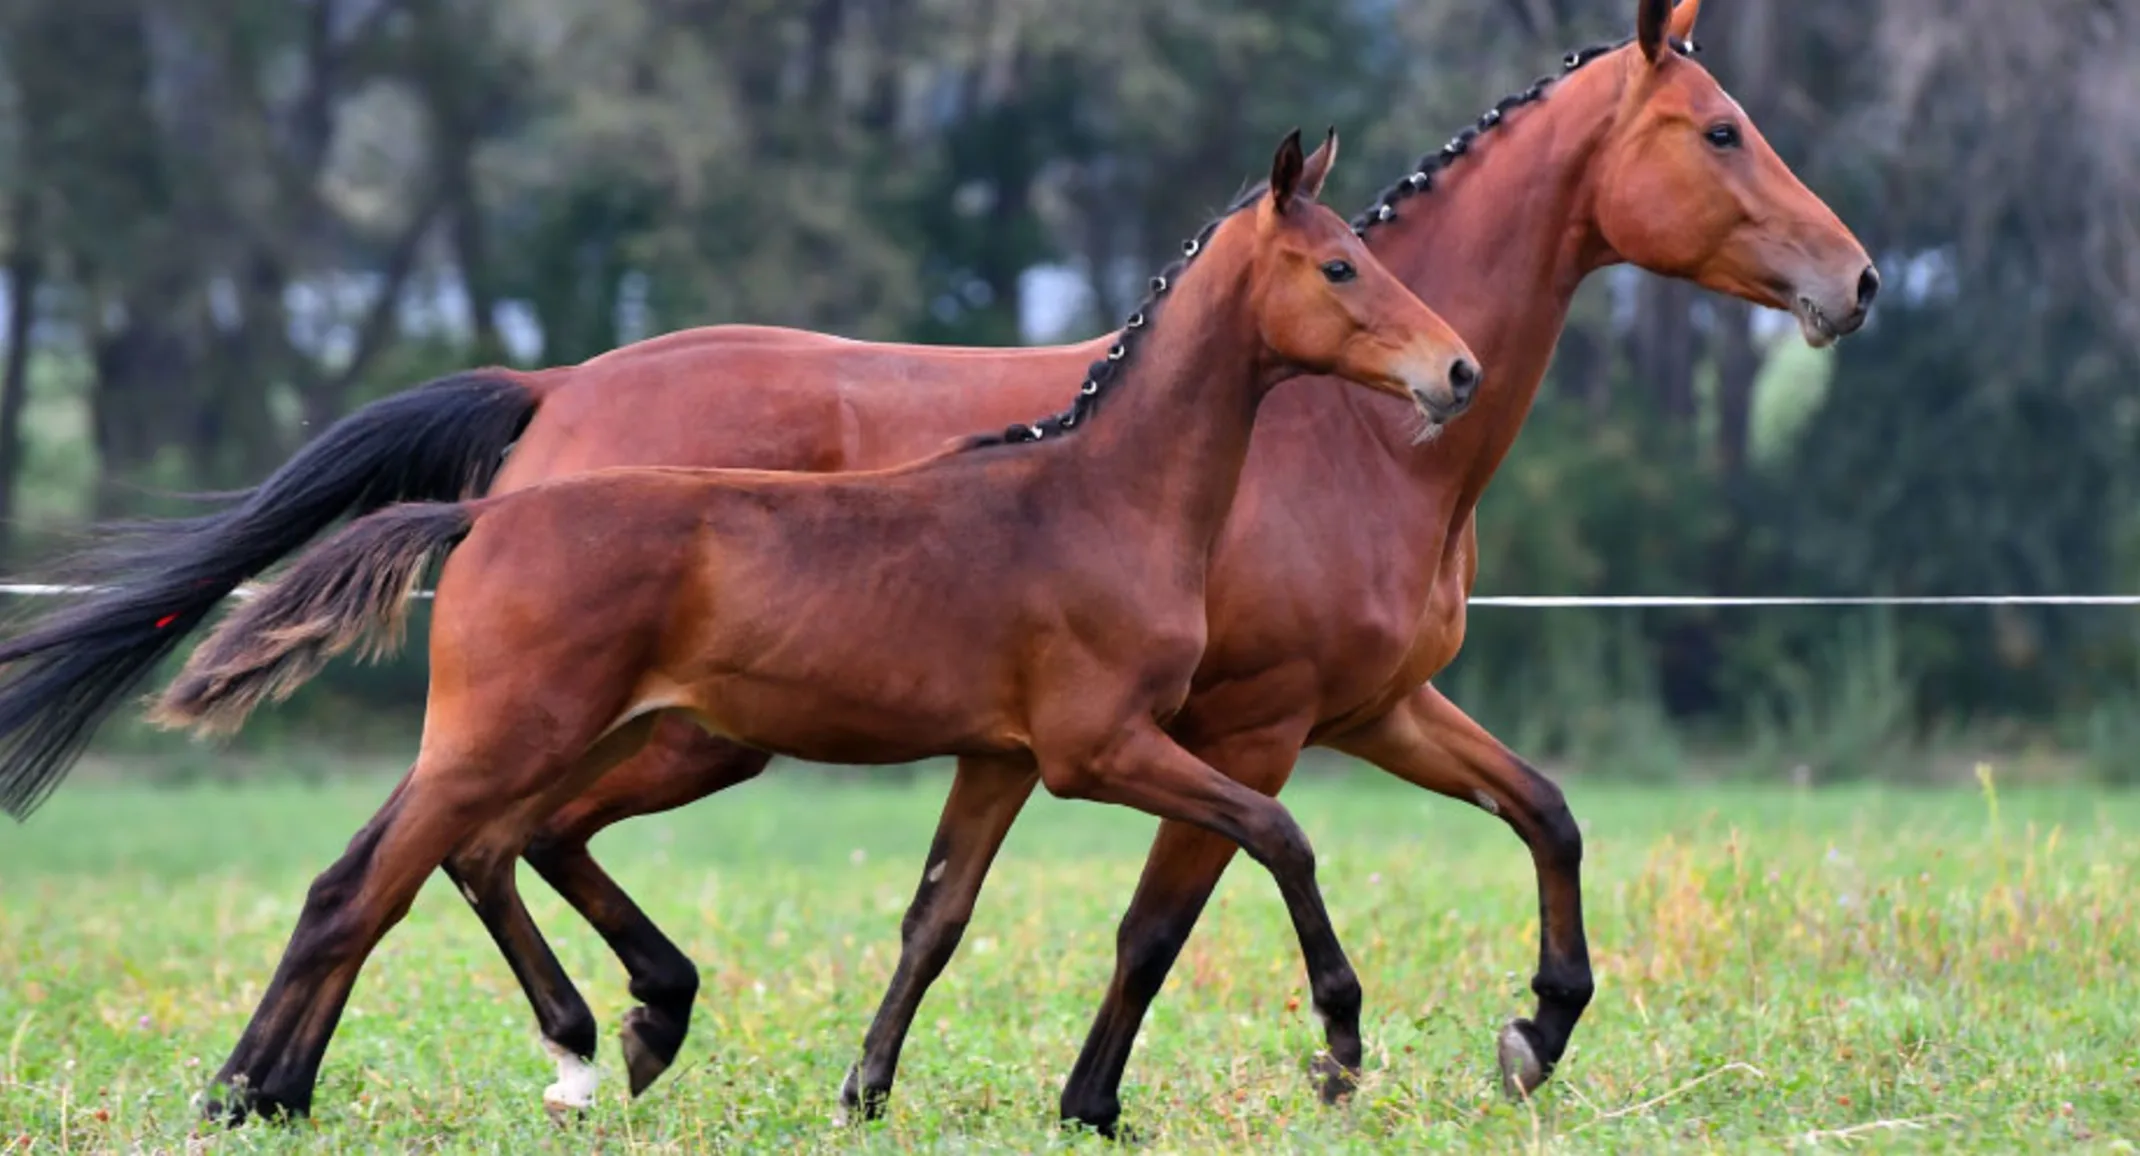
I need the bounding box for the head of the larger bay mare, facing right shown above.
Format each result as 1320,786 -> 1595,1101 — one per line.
1584,0 -> 1879,347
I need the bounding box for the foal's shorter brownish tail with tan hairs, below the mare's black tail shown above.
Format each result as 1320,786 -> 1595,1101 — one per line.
150,503 -> 475,734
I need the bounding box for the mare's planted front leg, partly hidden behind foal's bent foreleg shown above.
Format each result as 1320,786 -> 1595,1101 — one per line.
1061,721 -> 1301,1135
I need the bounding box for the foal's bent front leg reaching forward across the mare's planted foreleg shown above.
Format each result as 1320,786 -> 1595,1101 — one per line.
1040,724 -> 1361,1135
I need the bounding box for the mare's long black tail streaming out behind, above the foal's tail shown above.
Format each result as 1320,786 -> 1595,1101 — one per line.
0,370 -> 539,820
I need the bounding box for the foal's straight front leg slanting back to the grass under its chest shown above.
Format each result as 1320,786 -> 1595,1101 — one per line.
839,758 -> 1040,1120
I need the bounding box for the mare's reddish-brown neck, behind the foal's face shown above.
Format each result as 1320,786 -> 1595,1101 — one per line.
1355,60 -> 1624,518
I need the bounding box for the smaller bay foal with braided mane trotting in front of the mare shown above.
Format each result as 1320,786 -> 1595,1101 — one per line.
146,133 -> 1479,1117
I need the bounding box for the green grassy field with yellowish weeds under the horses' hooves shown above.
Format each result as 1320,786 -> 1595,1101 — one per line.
0,753 -> 2140,1152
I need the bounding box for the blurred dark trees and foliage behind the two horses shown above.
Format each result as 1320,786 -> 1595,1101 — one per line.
0,0 -> 2140,781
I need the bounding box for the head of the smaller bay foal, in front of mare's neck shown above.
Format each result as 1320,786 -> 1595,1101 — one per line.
1237,131 -> 1481,424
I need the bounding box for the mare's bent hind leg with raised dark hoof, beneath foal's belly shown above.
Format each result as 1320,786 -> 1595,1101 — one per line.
516,717 -> 773,1096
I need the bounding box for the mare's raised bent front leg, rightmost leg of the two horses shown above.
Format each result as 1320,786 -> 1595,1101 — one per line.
1329,685 -> 1594,1098
